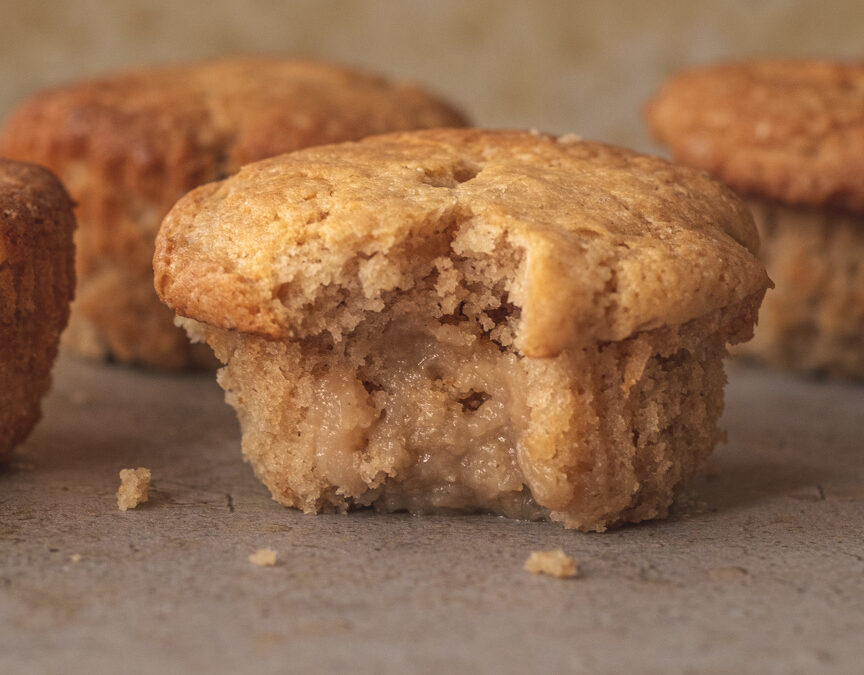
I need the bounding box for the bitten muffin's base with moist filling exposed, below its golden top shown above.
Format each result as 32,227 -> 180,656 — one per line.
184,286 -> 761,531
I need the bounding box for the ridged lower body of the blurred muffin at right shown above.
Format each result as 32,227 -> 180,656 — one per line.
737,199 -> 864,379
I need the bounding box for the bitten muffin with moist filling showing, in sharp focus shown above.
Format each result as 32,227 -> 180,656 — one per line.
154,129 -> 769,530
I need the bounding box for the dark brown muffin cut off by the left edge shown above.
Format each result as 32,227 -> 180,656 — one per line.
0,159 -> 75,460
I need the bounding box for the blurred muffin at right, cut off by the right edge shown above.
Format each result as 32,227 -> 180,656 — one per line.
646,61 -> 864,378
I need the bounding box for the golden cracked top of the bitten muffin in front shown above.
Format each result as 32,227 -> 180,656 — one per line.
154,129 -> 770,356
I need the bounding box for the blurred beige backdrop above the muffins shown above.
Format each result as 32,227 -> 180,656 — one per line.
0,0 -> 864,149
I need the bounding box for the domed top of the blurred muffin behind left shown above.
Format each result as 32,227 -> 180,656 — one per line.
0,57 -> 466,199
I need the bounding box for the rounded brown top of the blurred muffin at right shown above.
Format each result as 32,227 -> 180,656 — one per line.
646,61 -> 864,213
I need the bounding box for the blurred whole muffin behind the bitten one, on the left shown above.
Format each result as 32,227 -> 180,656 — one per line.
0,58 -> 465,368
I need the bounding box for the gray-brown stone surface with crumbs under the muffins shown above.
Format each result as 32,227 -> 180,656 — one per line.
0,360 -> 864,673
